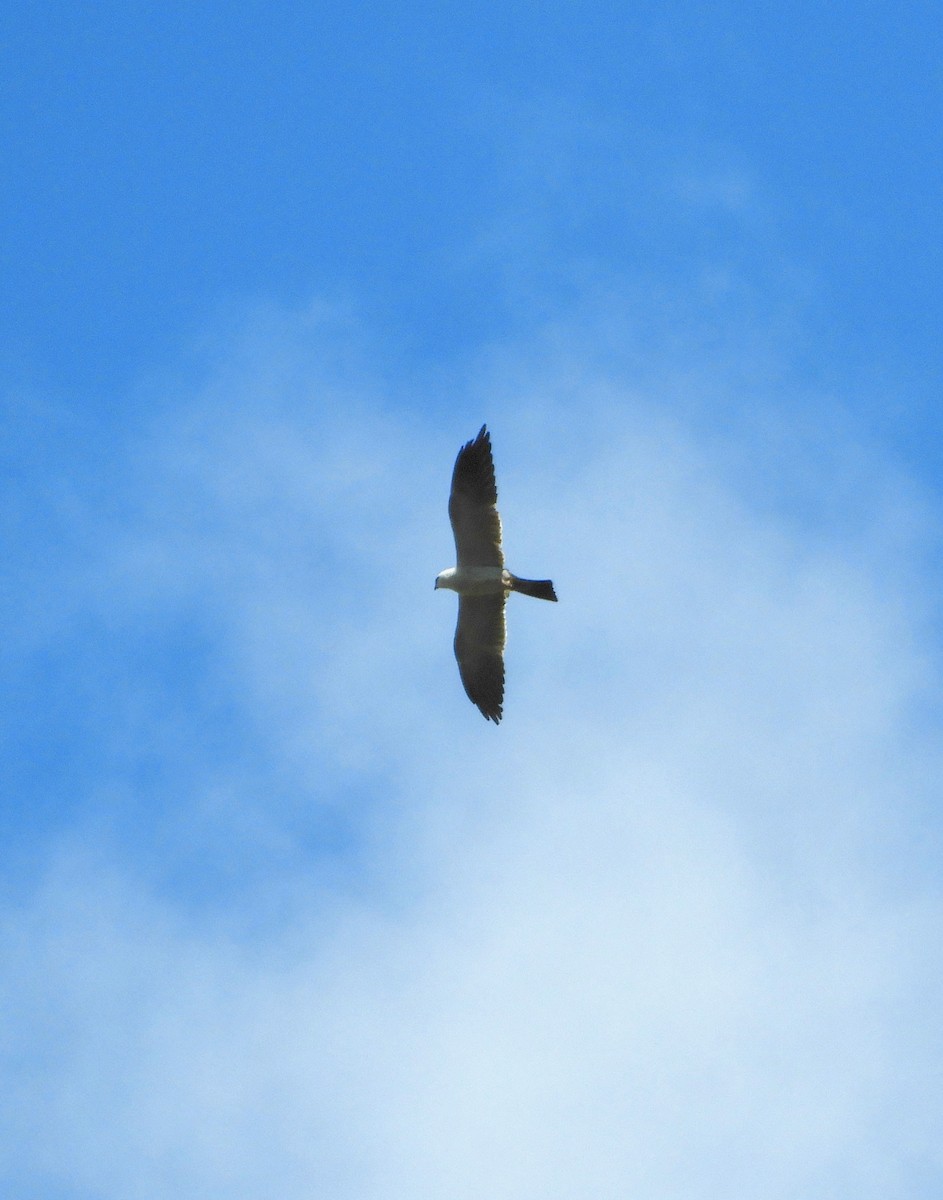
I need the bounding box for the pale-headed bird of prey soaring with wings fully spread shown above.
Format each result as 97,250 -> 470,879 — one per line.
436,425 -> 557,725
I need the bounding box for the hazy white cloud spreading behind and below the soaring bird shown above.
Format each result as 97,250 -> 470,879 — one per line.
2,312 -> 943,1200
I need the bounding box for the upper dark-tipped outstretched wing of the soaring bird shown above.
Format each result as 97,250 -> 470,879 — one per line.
449,425 -> 504,566
